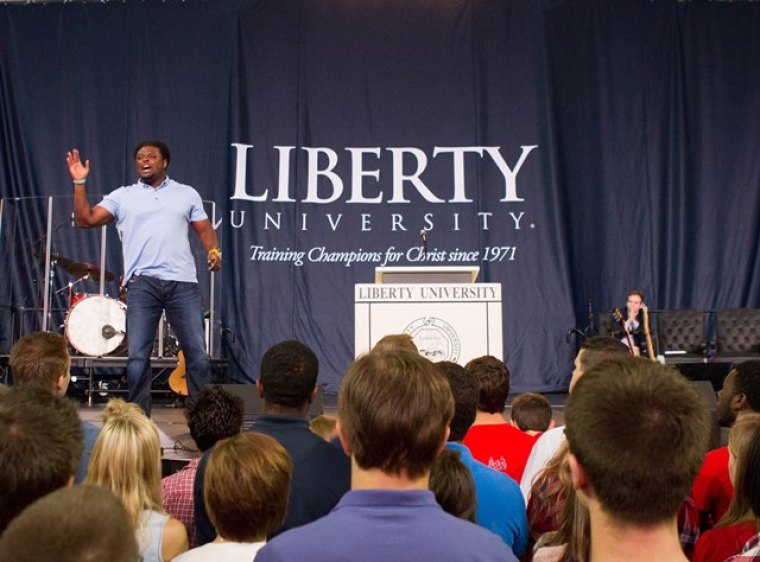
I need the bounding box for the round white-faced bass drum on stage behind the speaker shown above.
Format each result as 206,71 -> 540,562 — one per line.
66,295 -> 127,357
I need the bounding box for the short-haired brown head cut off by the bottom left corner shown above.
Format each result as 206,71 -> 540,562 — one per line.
0,485 -> 138,562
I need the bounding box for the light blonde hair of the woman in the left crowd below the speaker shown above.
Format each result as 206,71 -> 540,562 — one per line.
85,399 -> 163,526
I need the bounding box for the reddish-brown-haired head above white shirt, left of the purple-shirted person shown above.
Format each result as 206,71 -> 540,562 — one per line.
204,433 -> 293,542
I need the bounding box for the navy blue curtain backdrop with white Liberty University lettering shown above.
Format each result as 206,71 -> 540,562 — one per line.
0,0 -> 760,392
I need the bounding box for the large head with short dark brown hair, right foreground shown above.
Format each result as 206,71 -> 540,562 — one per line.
565,358 -> 710,525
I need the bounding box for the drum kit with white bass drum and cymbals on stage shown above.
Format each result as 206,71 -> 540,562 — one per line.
50,254 -> 127,357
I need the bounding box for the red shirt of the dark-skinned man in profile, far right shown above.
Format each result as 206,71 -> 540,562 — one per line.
691,447 -> 734,525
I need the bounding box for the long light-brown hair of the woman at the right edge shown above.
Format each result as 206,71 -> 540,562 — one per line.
715,413 -> 760,530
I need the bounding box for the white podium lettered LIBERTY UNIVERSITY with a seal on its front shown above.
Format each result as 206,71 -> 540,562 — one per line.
354,266 -> 504,365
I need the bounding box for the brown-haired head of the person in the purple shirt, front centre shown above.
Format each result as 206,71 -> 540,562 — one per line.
338,351 -> 454,480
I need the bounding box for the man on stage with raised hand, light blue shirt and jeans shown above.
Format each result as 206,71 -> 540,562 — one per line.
66,141 -> 222,415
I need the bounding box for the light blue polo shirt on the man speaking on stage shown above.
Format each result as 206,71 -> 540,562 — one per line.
98,177 -> 208,284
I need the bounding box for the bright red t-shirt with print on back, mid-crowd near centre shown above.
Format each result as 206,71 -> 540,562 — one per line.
463,423 -> 540,482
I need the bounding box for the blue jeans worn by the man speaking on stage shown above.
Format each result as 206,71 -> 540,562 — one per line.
127,275 -> 211,416
